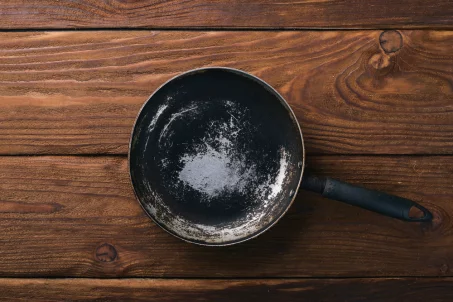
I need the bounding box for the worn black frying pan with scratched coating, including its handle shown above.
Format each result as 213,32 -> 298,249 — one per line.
129,67 -> 432,246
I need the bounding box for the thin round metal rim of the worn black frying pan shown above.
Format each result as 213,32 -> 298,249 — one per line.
127,66 -> 305,247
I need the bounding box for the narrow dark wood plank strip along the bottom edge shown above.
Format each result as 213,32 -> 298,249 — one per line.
0,278 -> 453,302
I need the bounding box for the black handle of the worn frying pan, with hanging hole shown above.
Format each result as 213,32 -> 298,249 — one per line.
301,175 -> 433,221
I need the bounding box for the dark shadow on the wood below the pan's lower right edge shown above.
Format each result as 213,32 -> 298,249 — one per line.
181,190 -> 316,277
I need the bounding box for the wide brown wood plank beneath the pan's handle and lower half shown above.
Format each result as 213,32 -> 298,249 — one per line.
0,156 -> 453,278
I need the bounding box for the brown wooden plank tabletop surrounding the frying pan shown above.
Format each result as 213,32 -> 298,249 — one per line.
0,0 -> 453,302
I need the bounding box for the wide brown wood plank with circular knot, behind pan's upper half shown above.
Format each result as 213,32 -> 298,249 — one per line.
0,31 -> 453,154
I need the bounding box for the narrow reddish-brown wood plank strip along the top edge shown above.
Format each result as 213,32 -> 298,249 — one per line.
0,0 -> 453,29
